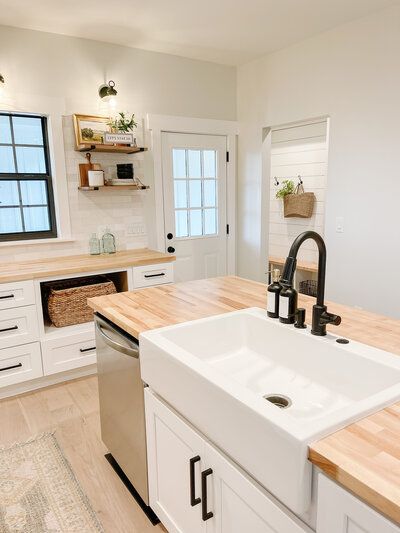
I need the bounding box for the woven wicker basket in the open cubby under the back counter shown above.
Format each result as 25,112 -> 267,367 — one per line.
44,276 -> 117,328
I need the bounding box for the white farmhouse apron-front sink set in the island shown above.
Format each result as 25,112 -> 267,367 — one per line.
140,308 -> 400,514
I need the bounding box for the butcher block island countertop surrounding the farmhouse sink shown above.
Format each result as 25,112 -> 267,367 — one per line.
89,276 -> 400,524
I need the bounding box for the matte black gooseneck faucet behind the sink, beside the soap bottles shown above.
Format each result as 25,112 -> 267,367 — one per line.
281,231 -> 341,336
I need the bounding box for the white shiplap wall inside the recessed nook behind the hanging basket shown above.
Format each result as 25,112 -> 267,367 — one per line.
269,120 -> 328,262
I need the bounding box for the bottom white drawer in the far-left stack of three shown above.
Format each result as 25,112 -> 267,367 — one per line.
0,342 -> 43,387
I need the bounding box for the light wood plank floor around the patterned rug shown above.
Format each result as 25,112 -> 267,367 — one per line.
0,376 -> 166,533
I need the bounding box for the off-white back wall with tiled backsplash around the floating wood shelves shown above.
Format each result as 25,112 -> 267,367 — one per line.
0,26 -> 236,260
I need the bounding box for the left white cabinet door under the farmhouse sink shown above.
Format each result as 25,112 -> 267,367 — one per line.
145,388 -> 206,533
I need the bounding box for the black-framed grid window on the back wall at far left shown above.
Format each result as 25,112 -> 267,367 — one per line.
0,113 -> 57,241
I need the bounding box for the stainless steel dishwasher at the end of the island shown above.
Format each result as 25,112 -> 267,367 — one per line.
95,313 -> 155,522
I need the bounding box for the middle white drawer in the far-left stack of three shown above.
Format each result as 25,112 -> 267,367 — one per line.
0,305 -> 39,349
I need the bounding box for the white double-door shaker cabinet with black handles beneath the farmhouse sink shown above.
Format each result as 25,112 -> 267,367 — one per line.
145,389 -> 311,533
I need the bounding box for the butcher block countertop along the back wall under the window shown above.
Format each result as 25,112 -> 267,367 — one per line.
0,248 -> 175,283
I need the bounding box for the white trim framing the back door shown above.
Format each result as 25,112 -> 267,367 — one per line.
147,114 -> 239,275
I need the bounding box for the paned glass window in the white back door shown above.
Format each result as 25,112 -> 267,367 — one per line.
172,148 -> 218,238
